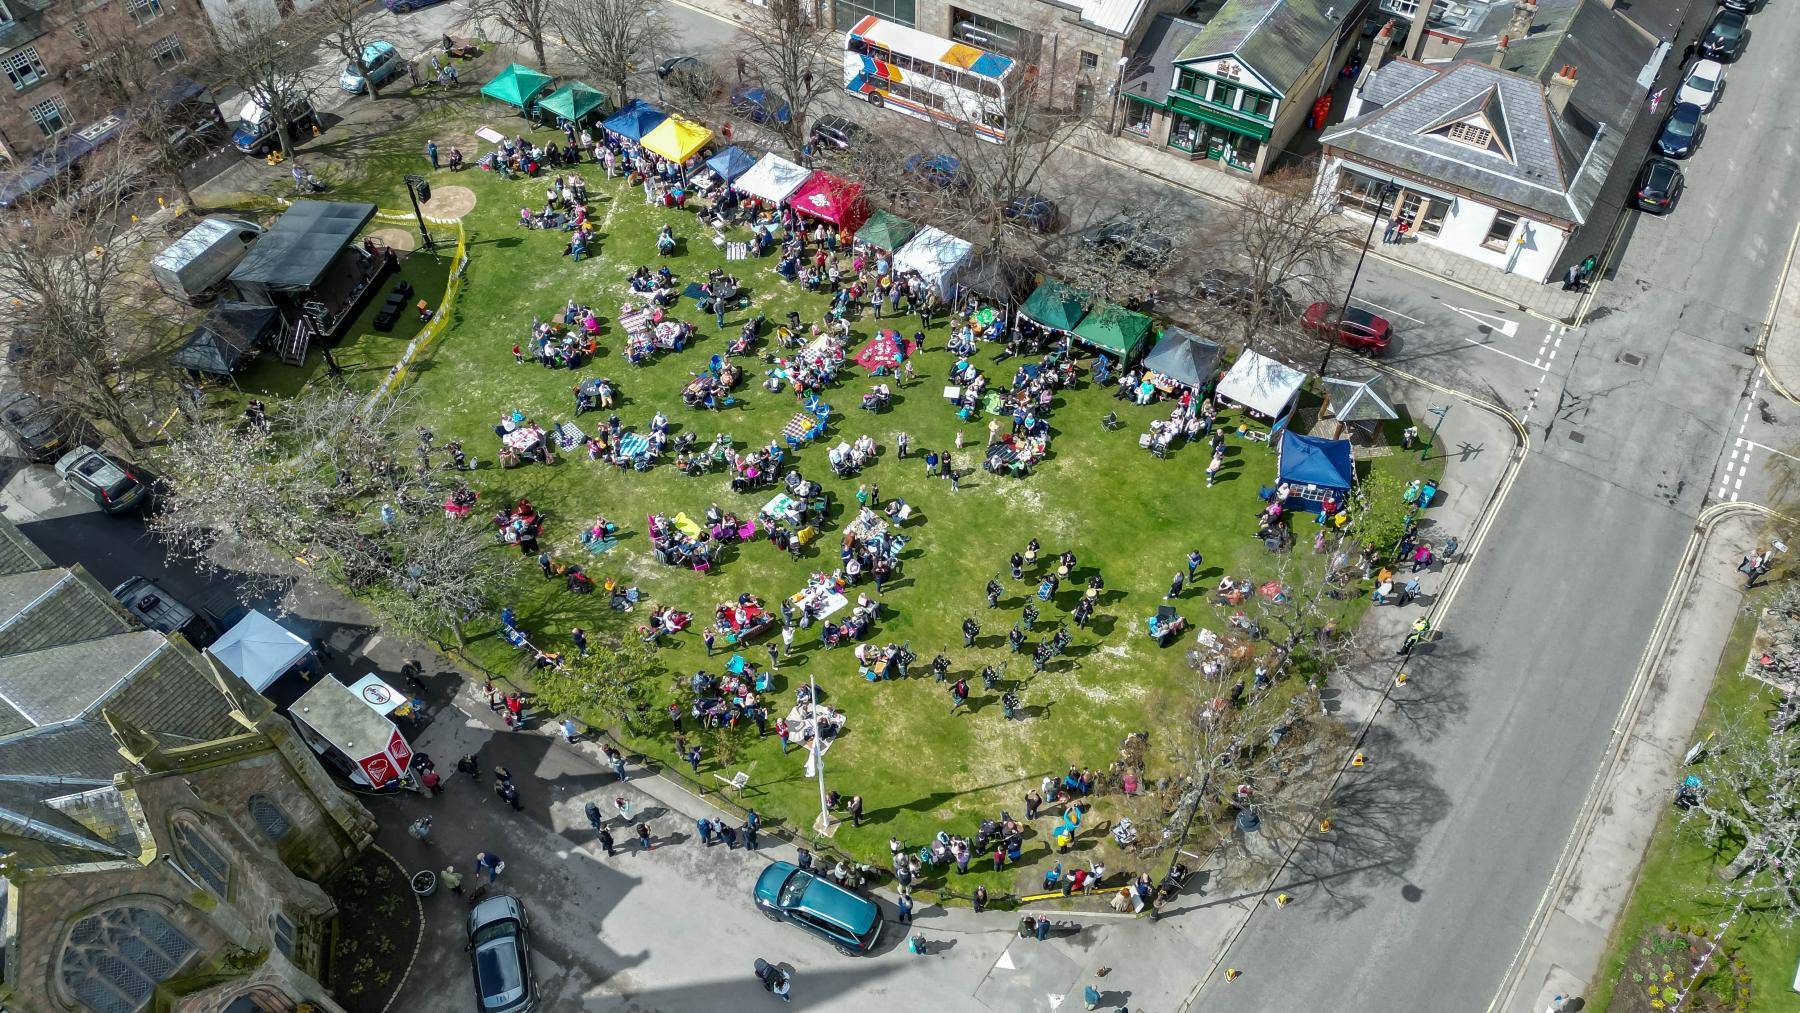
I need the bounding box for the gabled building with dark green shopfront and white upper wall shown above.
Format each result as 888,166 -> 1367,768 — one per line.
1121,0 -> 1372,178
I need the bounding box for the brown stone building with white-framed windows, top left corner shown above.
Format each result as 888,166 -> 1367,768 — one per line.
0,0 -> 214,182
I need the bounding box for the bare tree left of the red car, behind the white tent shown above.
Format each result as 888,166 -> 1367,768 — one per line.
1233,166 -> 1350,342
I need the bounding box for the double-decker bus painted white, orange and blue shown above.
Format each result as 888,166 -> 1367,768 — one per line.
844,14 -> 1013,140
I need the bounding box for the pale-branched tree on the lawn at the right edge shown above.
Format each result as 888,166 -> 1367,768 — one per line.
1679,716 -> 1800,925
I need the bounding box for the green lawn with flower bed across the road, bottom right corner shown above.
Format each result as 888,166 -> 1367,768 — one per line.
1588,612 -> 1800,1013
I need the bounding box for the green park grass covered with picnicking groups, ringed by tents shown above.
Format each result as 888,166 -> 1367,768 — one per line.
243,95 -> 1440,892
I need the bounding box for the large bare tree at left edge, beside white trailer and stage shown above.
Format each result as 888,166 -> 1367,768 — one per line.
0,154 -> 180,448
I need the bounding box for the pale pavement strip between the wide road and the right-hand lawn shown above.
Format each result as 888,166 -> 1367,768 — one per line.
1494,507 -> 1762,1013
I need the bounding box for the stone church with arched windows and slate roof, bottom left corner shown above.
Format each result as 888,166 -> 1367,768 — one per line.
0,520 -> 374,1013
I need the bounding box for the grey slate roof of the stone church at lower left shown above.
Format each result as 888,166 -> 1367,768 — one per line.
0,518 -> 241,867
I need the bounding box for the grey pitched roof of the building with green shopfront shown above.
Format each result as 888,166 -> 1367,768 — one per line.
1175,0 -> 1359,95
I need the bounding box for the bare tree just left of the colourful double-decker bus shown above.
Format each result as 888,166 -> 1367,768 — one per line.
738,0 -> 844,158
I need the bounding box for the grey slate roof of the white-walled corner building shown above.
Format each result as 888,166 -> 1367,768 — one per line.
1319,0 -> 1656,225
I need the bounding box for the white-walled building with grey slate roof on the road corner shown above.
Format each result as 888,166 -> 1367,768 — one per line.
1318,0 -> 1667,281
